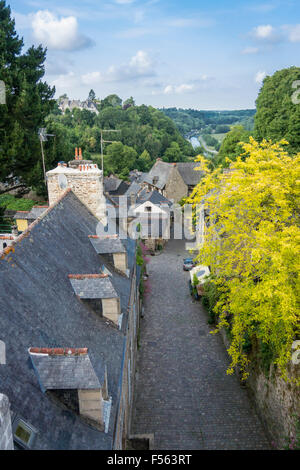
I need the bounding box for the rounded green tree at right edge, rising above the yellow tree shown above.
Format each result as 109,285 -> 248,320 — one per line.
254,67 -> 300,153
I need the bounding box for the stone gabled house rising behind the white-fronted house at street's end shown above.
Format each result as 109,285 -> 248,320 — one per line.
143,158 -> 202,202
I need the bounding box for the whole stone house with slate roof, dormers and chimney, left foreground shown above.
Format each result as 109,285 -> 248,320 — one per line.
0,160 -> 140,450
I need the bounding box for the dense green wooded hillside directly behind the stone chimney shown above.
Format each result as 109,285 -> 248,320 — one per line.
45,95 -> 195,177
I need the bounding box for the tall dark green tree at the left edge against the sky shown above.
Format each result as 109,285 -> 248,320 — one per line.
0,1 -> 55,191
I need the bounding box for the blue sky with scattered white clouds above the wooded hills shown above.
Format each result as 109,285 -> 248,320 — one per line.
7,0 -> 300,109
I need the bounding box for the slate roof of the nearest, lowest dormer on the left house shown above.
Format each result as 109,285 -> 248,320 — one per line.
30,354 -> 104,391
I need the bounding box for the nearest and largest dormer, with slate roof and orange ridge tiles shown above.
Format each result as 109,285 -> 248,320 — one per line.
27,348 -> 110,434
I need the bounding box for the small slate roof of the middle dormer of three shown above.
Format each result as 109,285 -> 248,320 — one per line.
70,277 -> 119,299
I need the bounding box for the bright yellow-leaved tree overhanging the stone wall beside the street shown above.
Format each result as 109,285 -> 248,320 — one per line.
186,138 -> 300,384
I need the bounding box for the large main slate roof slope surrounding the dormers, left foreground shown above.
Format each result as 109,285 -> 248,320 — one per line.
0,191 -> 136,450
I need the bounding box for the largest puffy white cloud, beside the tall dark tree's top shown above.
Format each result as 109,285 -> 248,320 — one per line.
31,10 -> 92,51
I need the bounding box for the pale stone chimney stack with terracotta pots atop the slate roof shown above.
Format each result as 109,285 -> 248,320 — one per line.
47,148 -> 106,222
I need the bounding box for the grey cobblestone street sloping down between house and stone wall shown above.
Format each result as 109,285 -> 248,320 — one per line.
132,240 -> 269,450
